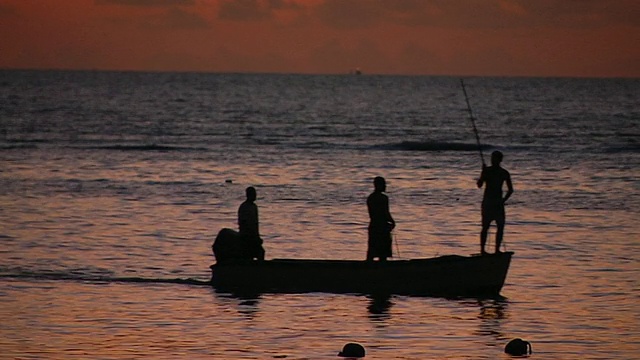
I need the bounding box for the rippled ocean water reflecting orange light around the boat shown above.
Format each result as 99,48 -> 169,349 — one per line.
0,70 -> 640,359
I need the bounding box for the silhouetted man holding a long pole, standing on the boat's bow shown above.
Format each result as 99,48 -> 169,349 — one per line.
478,151 -> 513,255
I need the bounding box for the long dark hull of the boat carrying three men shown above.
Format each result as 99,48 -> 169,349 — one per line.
211,252 -> 513,297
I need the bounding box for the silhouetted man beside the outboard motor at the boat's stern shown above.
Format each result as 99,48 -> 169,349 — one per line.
238,186 -> 264,260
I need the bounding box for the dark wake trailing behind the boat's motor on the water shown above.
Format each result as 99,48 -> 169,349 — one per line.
0,269 -> 211,286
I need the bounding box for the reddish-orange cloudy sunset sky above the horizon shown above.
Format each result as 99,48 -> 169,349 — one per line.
0,0 -> 640,78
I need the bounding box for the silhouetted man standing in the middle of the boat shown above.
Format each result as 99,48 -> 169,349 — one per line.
367,176 -> 396,261
